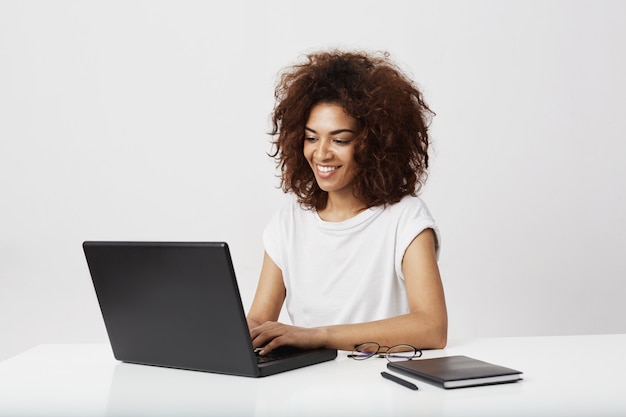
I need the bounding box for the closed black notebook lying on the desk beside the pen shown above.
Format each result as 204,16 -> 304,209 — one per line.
387,356 -> 522,388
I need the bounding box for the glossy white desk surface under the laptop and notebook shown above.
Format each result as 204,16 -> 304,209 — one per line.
0,335 -> 626,417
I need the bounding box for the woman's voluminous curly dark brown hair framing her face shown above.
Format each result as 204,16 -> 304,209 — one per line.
270,50 -> 434,210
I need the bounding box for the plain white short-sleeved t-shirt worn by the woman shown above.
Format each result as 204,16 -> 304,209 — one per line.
263,196 -> 441,327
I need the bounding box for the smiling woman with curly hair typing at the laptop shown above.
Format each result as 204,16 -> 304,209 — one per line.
247,51 -> 447,354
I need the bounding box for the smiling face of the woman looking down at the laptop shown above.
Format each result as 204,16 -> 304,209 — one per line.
304,103 -> 359,196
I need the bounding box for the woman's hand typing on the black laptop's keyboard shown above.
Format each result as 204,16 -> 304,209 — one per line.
250,321 -> 324,355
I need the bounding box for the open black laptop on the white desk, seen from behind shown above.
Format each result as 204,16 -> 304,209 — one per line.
83,241 -> 337,377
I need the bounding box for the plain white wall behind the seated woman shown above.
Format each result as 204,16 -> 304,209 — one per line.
0,0 -> 626,359
